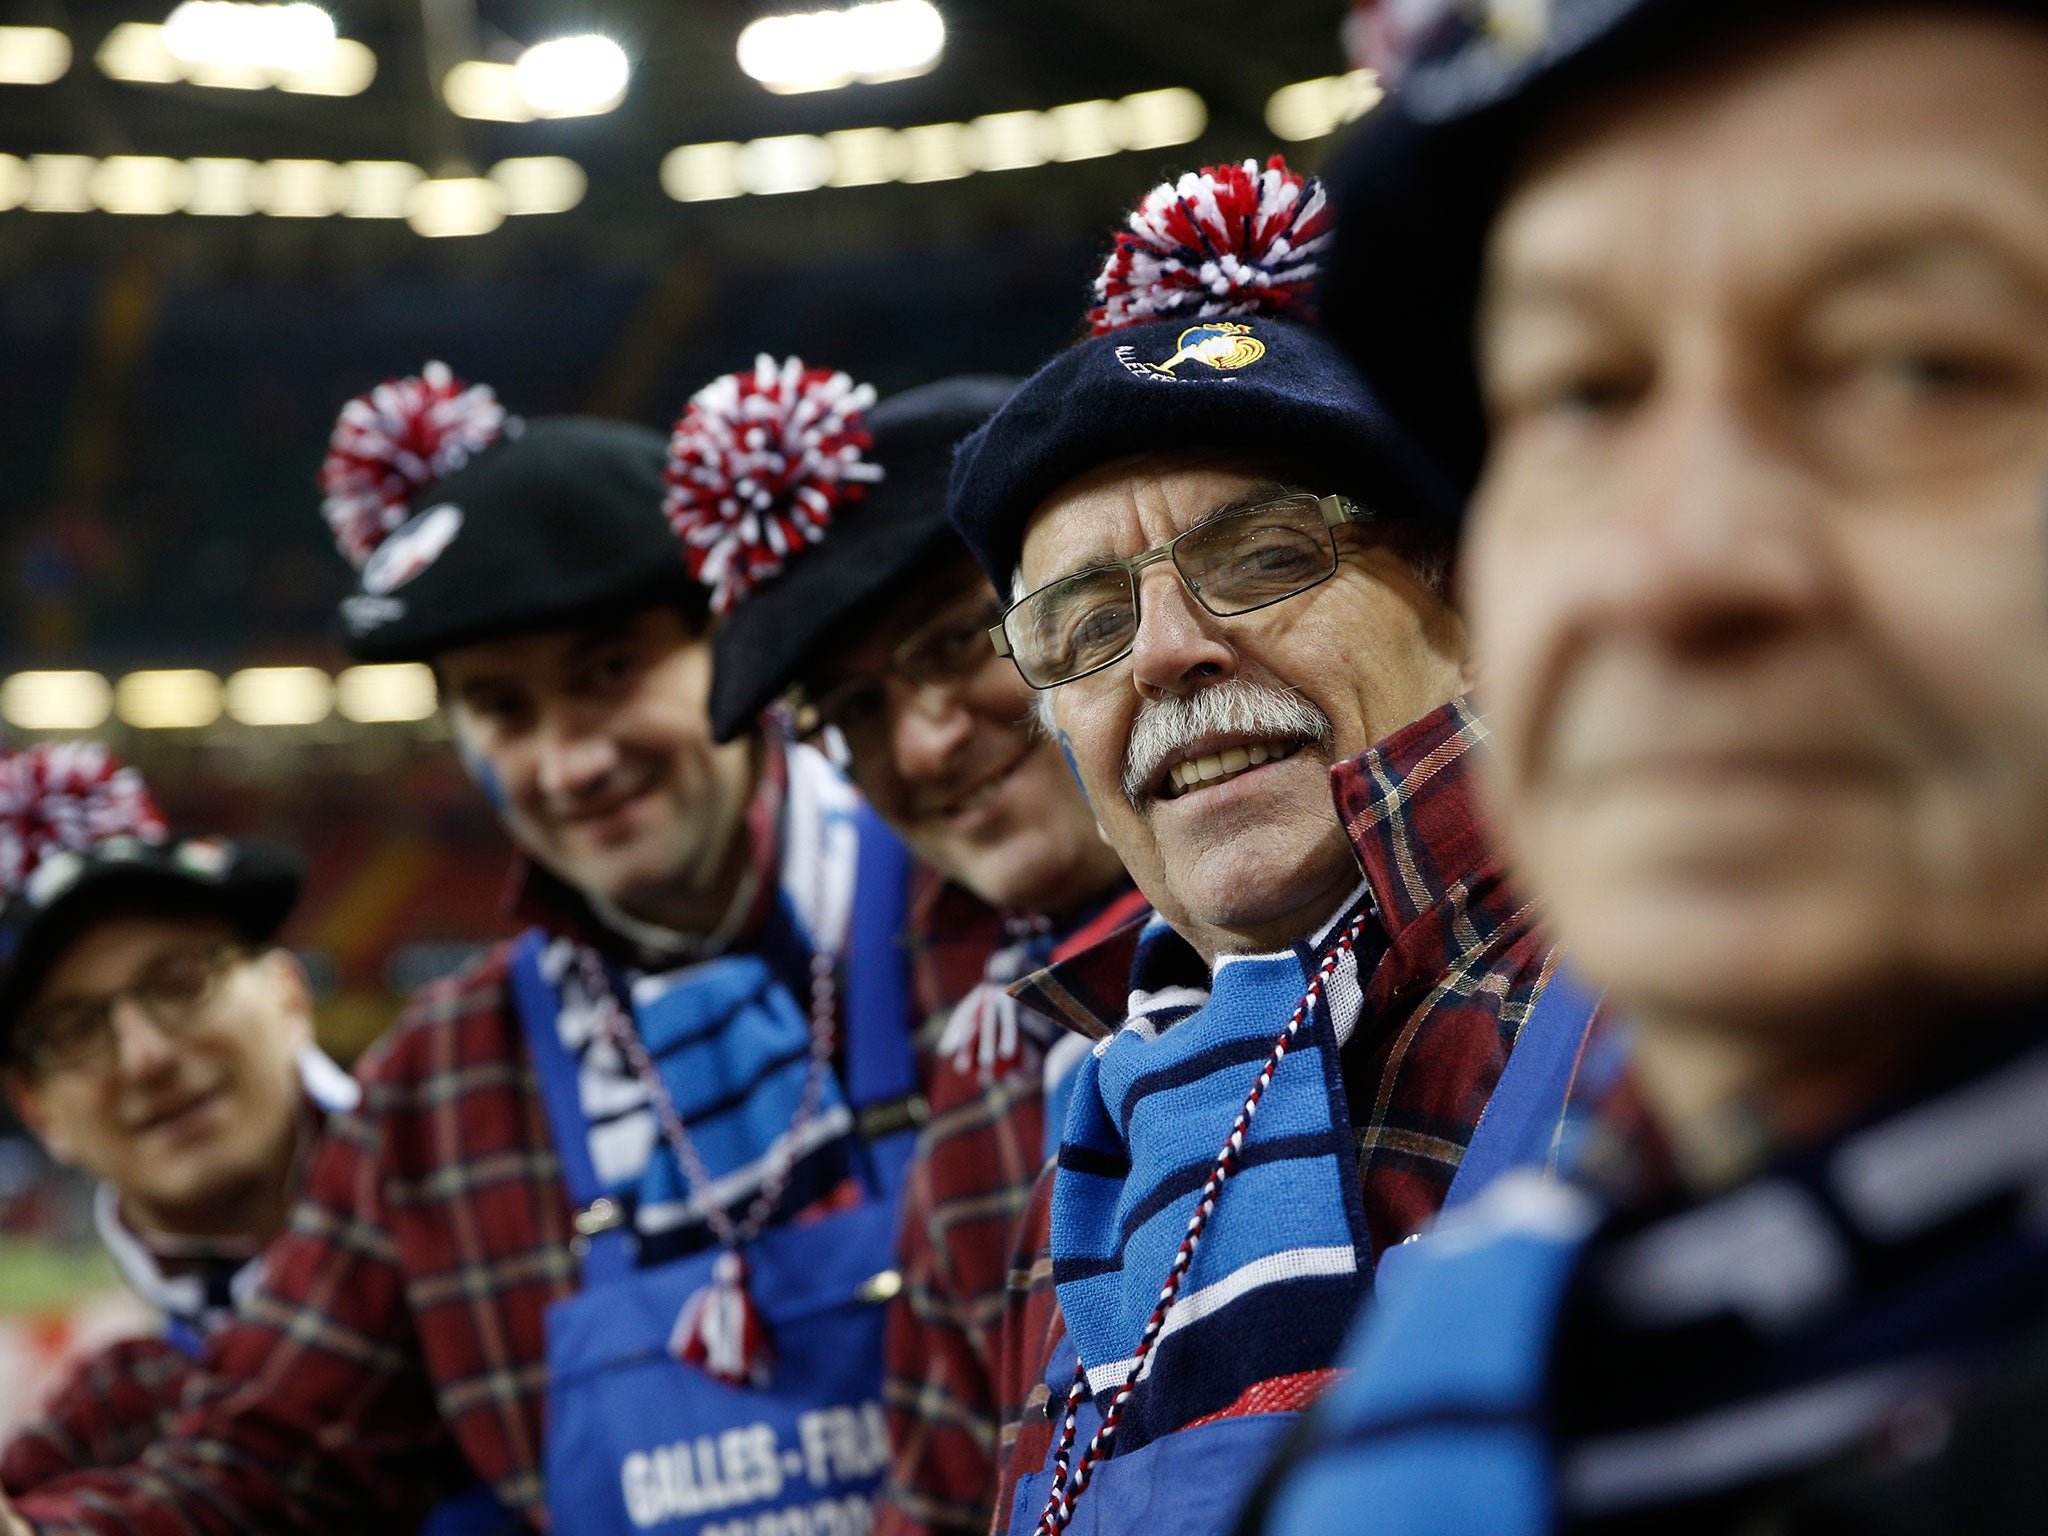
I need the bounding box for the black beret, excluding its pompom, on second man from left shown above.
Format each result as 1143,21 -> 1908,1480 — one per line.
340,416 -> 705,662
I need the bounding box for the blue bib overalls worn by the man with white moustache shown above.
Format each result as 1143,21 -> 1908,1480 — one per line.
1008,971 -> 1599,1536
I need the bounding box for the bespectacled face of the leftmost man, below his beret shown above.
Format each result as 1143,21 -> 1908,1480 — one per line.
14,915 -> 313,1237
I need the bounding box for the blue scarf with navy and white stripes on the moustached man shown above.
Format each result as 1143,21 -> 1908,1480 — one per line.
1051,889 -> 1384,1450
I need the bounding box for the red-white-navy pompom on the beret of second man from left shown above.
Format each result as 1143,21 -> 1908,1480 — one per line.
319,362 -> 518,571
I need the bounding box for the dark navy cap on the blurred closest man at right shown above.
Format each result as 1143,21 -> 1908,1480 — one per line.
1321,0 -> 2048,494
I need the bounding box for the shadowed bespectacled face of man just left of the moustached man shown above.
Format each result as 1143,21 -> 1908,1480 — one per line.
811,555 -> 1122,915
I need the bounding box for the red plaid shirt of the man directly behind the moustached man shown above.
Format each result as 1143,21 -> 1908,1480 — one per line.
874,885 -> 1147,1536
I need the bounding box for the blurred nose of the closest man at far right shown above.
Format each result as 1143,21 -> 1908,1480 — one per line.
1595,383 -> 1841,649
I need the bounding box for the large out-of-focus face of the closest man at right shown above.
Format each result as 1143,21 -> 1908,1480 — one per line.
1466,10 -> 2048,1040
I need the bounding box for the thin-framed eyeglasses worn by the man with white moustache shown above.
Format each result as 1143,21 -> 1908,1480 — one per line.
989,492 -> 1374,688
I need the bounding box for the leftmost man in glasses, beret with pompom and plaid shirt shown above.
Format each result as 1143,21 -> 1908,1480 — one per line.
0,741 -> 356,1493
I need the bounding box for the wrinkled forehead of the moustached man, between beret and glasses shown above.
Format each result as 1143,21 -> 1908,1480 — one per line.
1018,453 -> 1313,590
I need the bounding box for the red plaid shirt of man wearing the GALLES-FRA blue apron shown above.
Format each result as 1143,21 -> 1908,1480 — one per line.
18,741 -> 929,1536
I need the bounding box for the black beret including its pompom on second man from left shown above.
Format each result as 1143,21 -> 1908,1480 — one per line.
322,365 -> 705,662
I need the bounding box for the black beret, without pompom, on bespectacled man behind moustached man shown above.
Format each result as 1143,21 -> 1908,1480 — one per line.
711,375 -> 1016,741
